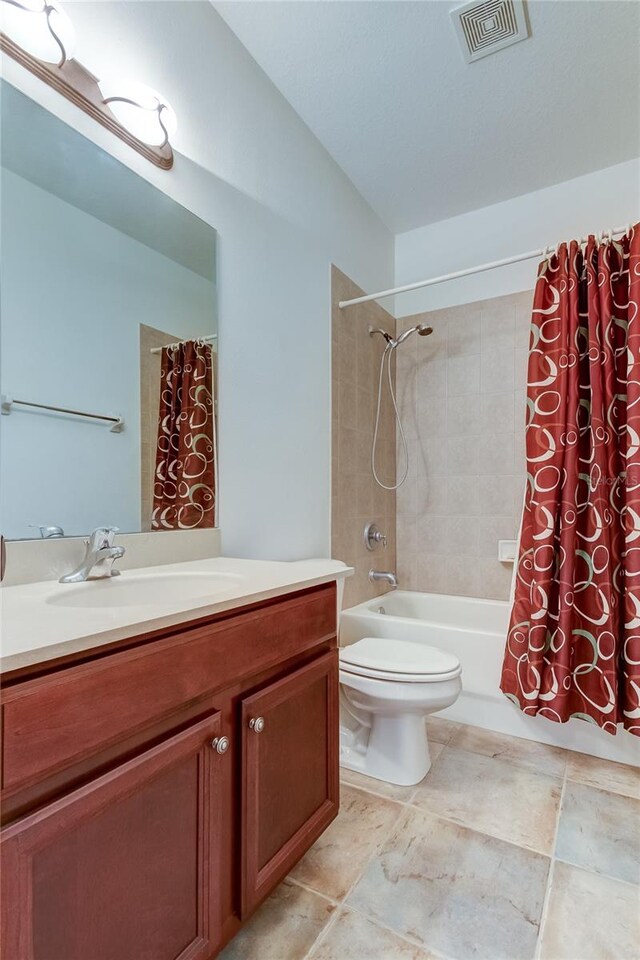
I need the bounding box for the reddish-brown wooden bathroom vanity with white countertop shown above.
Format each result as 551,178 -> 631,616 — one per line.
1,560 -> 349,960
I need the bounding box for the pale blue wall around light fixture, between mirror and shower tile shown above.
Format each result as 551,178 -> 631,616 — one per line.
5,2 -> 393,559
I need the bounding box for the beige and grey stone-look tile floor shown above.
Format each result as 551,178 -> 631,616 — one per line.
222,718 -> 640,960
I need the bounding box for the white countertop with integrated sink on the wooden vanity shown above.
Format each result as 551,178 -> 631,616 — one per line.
0,557 -> 353,672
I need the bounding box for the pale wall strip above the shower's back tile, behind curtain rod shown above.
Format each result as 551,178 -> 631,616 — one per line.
396,159 -> 640,317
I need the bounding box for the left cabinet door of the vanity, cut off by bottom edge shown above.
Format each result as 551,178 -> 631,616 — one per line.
1,714 -> 228,960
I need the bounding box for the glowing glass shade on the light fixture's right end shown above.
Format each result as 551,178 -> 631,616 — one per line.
98,79 -> 178,147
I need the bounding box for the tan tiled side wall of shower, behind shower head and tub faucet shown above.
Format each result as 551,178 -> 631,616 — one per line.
331,267 -> 396,607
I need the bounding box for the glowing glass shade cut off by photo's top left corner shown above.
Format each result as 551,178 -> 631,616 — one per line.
0,0 -> 76,67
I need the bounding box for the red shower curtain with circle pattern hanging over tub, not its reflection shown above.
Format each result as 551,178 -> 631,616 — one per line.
501,224 -> 640,736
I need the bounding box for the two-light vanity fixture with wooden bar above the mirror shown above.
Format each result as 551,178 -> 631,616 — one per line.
0,0 -> 177,170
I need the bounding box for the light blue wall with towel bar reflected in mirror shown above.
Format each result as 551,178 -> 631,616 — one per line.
0,169 -> 215,539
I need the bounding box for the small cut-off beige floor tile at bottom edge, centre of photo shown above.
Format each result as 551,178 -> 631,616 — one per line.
309,907 -> 431,960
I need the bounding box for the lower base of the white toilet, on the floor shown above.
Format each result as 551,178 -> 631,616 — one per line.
340,713 -> 431,787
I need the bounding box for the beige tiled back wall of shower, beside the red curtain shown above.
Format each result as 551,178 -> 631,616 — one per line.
397,291 -> 533,600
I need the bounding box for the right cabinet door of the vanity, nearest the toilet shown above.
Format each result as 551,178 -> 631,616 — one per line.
241,650 -> 339,917
